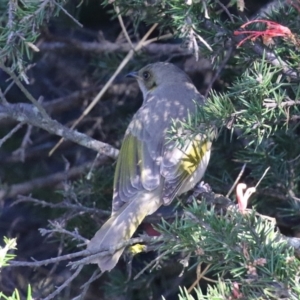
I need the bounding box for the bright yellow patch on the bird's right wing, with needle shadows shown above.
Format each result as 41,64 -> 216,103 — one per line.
180,139 -> 208,175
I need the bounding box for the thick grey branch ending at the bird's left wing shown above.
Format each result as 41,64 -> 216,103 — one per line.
0,103 -> 119,159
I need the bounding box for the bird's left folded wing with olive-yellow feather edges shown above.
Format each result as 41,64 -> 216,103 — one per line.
113,97 -> 164,213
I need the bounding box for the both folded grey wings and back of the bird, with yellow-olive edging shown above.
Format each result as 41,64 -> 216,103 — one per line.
113,87 -> 211,213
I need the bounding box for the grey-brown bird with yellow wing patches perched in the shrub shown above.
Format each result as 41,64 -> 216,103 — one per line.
87,62 -> 214,272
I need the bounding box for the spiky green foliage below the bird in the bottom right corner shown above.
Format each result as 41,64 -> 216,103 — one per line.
160,202 -> 300,300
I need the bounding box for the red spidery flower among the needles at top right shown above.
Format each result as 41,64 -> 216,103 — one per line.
234,20 -> 294,47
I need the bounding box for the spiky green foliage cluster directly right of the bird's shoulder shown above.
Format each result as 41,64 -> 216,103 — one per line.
199,58 -> 300,211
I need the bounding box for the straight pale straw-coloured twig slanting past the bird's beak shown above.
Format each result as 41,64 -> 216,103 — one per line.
49,23 -> 158,156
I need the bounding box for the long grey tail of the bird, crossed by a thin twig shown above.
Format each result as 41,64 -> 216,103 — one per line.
87,191 -> 162,272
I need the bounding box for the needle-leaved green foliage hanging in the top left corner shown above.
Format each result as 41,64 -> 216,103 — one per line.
0,0 -> 66,82
